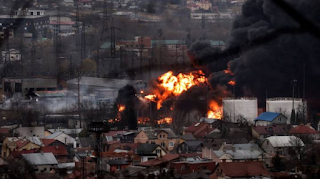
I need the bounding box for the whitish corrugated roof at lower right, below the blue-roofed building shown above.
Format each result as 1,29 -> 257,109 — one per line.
265,136 -> 304,147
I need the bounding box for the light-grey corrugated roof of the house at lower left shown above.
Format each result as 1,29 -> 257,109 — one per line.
22,153 -> 58,165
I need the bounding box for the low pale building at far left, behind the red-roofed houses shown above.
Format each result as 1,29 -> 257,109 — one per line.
13,126 -> 44,138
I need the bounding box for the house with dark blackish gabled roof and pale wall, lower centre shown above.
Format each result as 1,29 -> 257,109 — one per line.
136,143 -> 167,162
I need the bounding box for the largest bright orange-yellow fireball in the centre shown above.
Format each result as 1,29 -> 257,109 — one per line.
145,70 -> 207,109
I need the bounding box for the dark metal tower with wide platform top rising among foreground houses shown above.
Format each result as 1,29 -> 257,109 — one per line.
88,122 -> 109,179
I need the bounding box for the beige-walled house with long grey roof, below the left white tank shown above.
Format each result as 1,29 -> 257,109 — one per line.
209,144 -> 263,162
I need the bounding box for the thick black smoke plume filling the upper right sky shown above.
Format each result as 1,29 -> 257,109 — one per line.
190,0 -> 320,104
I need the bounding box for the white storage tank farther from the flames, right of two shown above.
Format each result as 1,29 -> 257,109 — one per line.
266,97 -> 307,121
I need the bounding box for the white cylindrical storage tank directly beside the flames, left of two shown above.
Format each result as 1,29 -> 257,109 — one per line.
222,97 -> 258,123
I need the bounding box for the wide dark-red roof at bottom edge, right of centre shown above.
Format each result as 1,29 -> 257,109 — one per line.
218,161 -> 269,177
